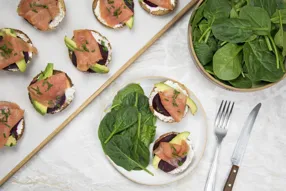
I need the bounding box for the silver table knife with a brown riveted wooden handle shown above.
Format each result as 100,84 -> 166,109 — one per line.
223,103 -> 261,191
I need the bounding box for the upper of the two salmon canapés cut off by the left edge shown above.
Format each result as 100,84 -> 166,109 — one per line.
0,28 -> 37,72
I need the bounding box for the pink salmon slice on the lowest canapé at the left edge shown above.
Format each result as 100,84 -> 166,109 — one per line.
0,106 -> 24,148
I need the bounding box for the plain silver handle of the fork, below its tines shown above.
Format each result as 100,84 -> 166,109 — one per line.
205,144 -> 220,191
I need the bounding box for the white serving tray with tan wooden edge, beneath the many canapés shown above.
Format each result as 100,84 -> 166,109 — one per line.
0,0 -> 198,186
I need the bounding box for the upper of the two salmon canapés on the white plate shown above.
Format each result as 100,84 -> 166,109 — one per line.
149,80 -> 197,123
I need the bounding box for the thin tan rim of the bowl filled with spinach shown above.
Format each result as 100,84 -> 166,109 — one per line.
188,0 -> 286,92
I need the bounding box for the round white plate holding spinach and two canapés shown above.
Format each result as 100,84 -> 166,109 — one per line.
102,77 -> 207,186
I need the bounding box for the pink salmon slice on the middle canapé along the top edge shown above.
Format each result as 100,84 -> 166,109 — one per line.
99,0 -> 134,27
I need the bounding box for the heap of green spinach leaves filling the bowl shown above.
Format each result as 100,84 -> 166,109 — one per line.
190,0 -> 286,88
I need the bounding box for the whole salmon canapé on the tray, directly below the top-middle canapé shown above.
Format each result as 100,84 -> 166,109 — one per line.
65,29 -> 112,73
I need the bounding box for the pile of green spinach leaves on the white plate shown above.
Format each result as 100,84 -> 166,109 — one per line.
98,84 -> 157,175
